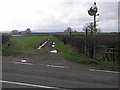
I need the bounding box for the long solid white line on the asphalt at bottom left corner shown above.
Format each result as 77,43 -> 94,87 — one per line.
0,80 -> 60,89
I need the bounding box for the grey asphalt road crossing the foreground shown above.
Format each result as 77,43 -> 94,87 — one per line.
1,61 -> 118,90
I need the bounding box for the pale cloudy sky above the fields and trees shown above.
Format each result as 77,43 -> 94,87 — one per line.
0,0 -> 118,32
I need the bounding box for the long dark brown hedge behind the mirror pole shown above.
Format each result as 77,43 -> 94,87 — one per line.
54,35 -> 118,57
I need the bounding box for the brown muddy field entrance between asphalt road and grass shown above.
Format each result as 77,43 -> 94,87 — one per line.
2,39 -> 92,68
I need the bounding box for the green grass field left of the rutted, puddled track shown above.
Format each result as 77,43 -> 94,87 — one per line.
3,36 -> 47,55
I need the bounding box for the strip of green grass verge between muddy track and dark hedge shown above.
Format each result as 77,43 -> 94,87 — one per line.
53,38 -> 120,71
